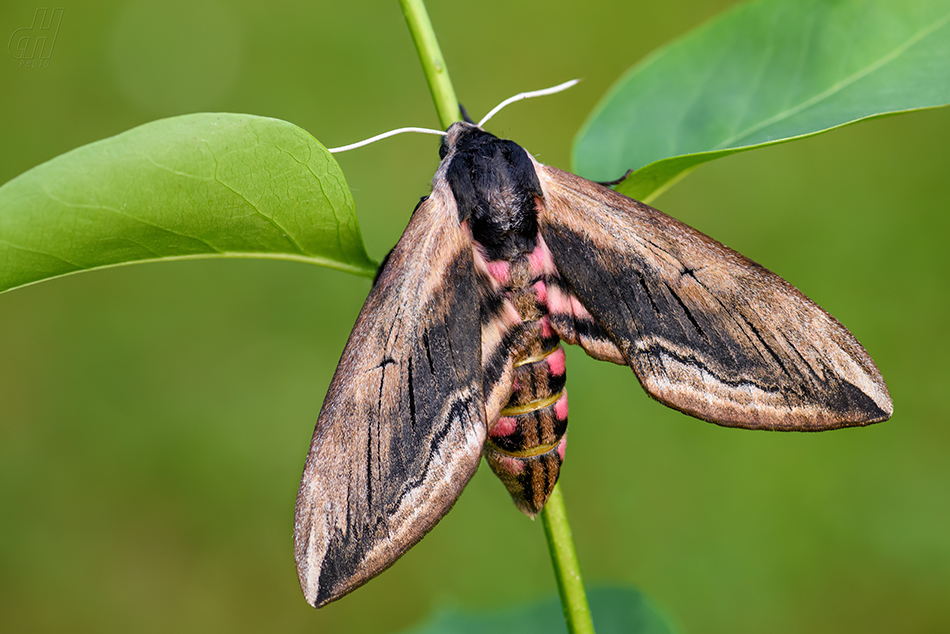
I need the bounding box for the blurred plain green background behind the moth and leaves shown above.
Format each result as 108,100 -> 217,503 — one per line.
0,0 -> 950,633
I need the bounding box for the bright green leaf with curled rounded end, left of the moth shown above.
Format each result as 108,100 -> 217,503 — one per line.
0,114 -> 376,291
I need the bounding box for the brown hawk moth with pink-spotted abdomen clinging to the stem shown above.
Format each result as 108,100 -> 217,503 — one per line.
294,122 -> 893,607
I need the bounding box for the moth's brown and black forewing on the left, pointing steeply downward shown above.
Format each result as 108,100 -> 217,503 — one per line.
295,187 -> 486,607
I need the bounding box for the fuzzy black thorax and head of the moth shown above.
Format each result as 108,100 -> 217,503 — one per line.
440,123 -> 541,260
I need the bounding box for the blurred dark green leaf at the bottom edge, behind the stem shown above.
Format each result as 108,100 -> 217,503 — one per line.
404,588 -> 676,634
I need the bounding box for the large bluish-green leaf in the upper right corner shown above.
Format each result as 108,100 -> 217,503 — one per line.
573,0 -> 950,200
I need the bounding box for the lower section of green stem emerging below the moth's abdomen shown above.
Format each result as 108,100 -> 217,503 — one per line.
541,485 -> 594,634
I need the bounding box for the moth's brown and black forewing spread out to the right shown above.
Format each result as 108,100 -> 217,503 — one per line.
536,164 -> 892,430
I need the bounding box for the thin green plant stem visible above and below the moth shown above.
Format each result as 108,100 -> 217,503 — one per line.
399,0 -> 594,634
